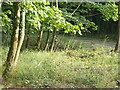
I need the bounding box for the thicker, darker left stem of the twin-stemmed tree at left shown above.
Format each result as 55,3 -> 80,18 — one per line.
3,2 -> 20,80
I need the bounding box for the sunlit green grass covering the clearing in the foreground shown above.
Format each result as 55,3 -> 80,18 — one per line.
0,32 -> 119,88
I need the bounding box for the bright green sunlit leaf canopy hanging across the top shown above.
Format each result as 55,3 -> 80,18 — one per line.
1,2 -> 118,35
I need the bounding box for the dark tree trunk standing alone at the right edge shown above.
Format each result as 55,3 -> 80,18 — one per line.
115,2 -> 120,52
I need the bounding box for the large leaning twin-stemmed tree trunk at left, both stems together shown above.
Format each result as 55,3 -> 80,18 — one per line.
3,2 -> 25,80
